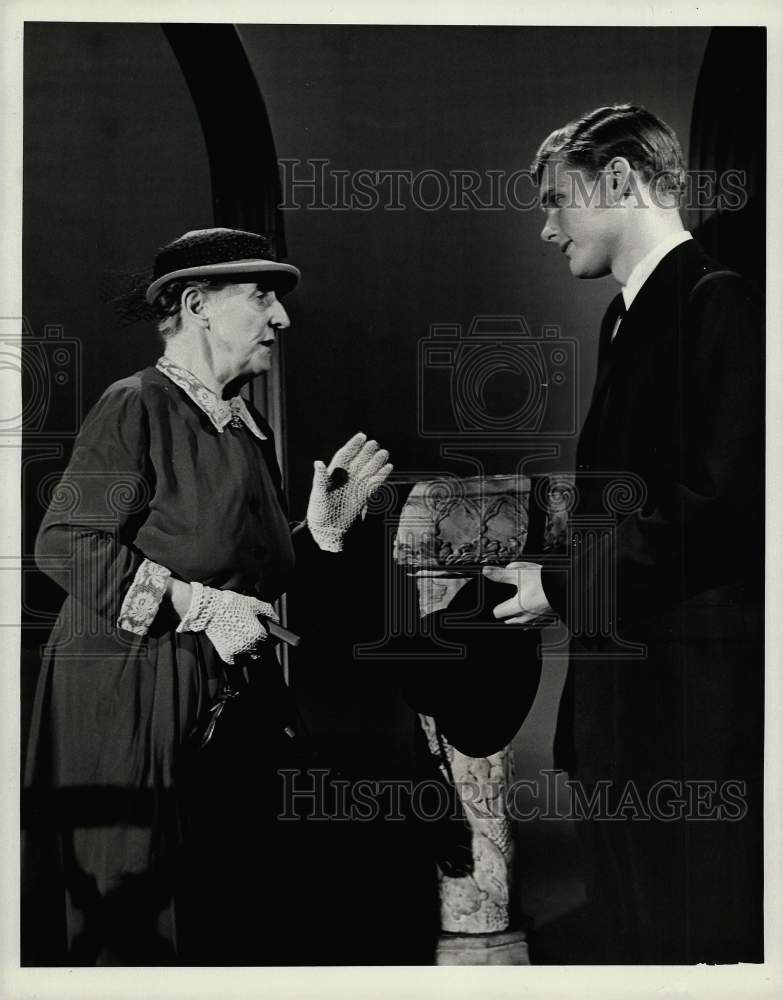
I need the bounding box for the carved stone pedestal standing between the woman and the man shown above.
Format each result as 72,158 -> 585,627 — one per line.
394,475 -> 569,965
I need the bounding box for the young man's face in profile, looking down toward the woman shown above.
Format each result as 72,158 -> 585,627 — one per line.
539,154 -> 622,278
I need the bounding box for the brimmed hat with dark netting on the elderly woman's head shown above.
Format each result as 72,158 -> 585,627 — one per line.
145,229 -> 301,305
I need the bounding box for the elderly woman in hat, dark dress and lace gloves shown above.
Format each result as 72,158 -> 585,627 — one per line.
25,229 -> 391,965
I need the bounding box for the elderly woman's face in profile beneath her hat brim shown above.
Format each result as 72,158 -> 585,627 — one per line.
202,281 -> 291,377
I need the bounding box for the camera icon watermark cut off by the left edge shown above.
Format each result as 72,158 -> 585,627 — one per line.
0,316 -> 82,441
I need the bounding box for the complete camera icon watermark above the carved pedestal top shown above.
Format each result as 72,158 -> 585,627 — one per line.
418,316 -> 579,440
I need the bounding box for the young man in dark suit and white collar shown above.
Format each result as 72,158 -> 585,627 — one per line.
485,105 -> 764,963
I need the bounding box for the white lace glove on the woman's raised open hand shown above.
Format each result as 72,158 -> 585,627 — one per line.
307,434 -> 393,552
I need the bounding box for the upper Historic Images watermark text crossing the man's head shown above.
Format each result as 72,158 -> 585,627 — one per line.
278,157 -> 748,212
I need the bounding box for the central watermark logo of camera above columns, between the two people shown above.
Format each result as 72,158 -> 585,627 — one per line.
354,315 -> 647,660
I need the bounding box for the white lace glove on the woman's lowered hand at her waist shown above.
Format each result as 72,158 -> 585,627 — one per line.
177,583 -> 280,663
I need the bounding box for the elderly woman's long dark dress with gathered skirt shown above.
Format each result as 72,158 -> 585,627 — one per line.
23,368 -> 310,964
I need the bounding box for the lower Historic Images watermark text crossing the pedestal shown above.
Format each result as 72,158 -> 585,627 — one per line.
277,768 -> 748,823
